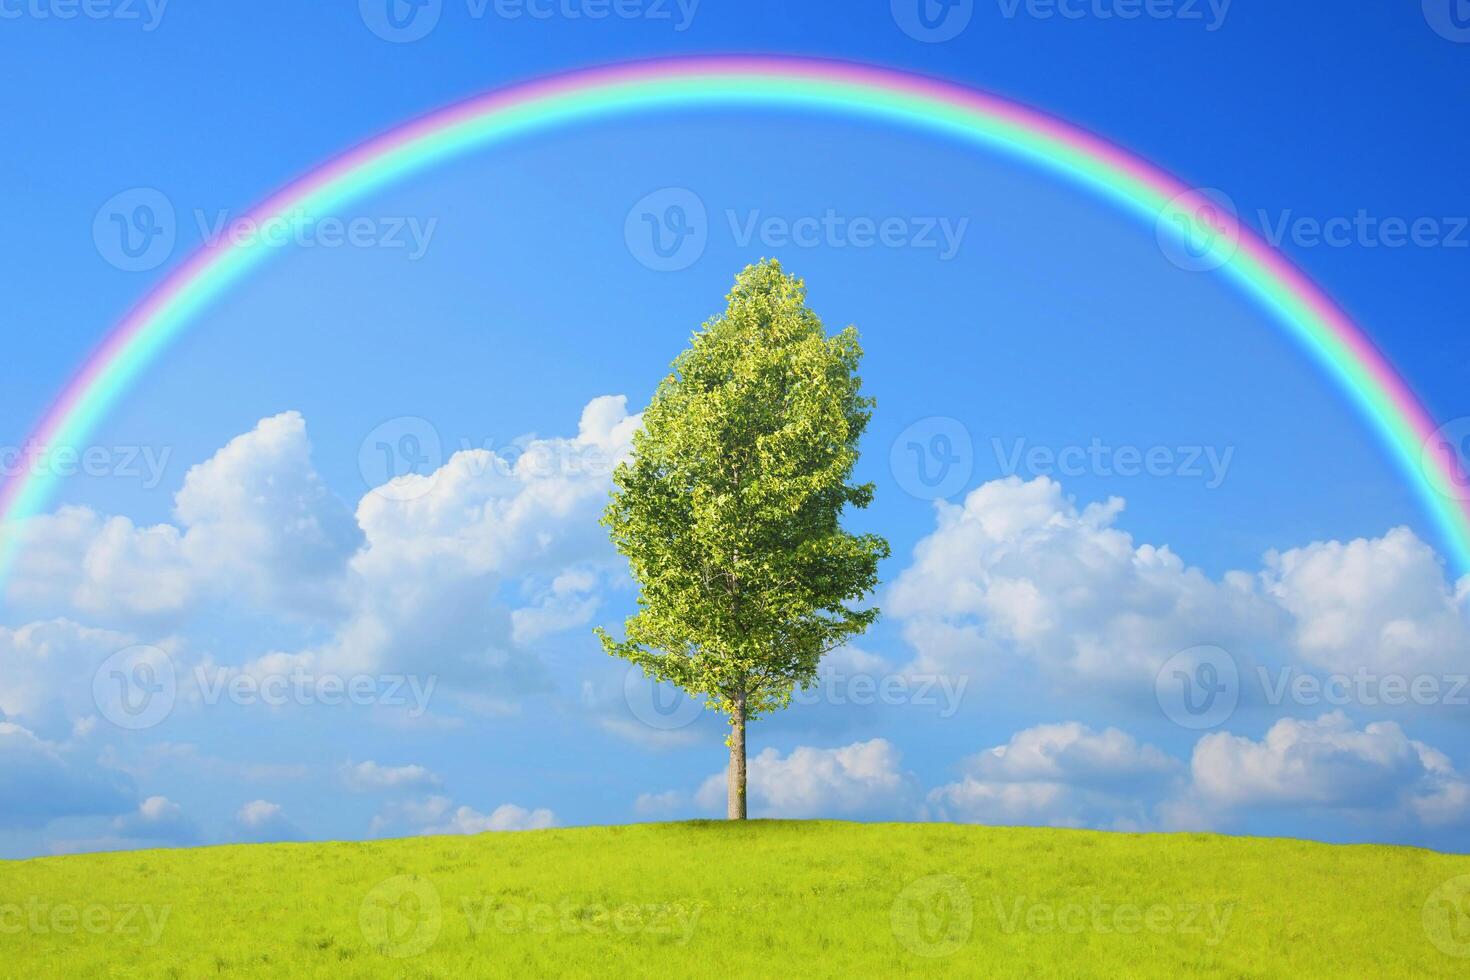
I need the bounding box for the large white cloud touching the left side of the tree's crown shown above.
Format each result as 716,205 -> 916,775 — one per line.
280,395 -> 641,695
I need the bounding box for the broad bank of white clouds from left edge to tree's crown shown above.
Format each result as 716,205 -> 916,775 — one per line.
0,395 -> 641,725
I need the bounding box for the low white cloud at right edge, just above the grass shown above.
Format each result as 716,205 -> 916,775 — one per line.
1191,711 -> 1470,826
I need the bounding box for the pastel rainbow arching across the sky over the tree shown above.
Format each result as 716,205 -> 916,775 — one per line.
0,57 -> 1470,574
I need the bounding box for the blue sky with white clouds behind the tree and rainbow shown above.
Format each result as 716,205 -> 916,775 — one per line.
0,0 -> 1470,855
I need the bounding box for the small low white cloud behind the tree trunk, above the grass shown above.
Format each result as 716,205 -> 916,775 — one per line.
695,739 -> 914,817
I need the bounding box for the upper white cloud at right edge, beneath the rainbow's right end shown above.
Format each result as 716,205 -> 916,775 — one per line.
1261,527 -> 1470,674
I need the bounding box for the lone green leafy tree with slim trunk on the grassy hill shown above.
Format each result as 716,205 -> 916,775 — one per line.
597,260 -> 888,820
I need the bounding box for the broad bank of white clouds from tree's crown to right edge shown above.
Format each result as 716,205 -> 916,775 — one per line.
885,476 -> 1470,692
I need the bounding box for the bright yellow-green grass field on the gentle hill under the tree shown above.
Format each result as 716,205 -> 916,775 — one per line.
0,821 -> 1470,980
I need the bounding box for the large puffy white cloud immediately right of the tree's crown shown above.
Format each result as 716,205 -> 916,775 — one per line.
885,476 -> 1274,689
